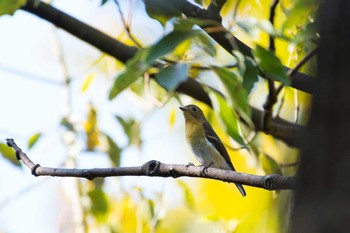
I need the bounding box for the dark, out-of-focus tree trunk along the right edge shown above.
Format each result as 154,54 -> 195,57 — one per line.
291,0 -> 350,233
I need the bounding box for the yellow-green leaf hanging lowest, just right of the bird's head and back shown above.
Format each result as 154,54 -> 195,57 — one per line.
209,91 -> 246,146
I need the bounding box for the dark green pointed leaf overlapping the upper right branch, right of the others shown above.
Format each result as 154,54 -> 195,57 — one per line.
253,45 -> 290,86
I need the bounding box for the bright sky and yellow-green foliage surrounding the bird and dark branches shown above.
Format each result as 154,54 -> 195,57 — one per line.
0,0 -> 318,232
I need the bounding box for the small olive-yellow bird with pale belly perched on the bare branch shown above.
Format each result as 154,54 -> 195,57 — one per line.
180,104 -> 246,197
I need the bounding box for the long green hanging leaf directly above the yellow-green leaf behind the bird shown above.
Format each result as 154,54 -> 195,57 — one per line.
212,66 -> 251,119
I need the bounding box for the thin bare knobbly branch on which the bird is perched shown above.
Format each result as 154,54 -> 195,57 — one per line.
6,139 -> 295,190
